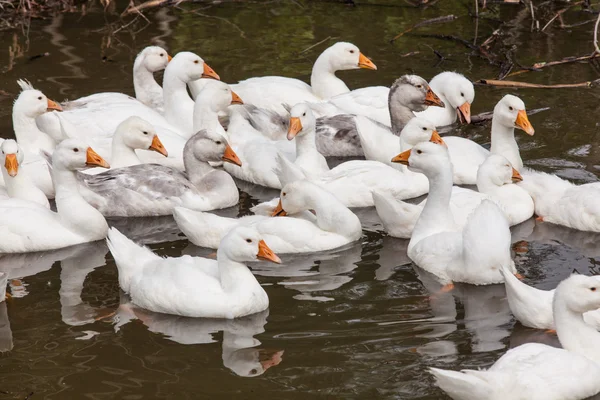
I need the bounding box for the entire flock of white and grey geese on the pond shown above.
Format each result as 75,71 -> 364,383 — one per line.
0,42 -> 600,400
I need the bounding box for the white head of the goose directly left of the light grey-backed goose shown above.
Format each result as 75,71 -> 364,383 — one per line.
52,139 -> 110,171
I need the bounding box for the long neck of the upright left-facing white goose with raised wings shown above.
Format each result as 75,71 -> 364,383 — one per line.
408,164 -> 455,249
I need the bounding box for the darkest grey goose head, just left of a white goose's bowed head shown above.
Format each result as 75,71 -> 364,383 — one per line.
388,75 -> 444,112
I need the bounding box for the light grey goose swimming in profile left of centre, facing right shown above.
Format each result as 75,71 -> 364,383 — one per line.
78,130 -> 240,217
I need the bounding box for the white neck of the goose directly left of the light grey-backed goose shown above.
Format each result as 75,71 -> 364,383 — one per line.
52,166 -> 108,240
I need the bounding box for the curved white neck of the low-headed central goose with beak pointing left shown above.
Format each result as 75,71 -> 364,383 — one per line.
305,191 -> 362,240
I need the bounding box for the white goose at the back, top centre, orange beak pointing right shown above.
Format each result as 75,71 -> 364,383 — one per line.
190,42 -> 377,115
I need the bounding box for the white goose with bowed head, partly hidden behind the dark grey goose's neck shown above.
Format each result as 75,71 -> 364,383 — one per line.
329,72 -> 475,126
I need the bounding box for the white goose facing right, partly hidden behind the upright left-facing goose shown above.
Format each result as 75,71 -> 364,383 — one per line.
373,155 -> 534,239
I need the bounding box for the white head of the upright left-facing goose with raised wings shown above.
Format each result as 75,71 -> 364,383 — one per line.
392,142 -> 452,177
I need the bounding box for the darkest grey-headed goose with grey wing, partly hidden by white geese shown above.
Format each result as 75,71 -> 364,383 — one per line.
311,75 -> 444,157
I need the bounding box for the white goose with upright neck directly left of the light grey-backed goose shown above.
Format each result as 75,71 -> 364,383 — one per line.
0,139 -> 109,253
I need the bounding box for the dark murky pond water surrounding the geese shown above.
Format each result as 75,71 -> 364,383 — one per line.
0,2 -> 600,400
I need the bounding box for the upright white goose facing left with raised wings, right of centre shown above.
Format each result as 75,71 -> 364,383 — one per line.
397,142 -> 516,285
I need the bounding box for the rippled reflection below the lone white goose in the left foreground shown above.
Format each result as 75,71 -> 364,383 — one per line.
114,293 -> 283,377
